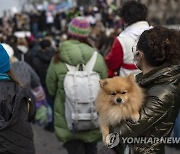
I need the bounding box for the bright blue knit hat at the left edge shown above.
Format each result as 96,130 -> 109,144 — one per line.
0,44 -> 10,73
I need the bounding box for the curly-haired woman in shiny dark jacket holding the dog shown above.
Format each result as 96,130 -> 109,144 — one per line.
110,26 -> 180,154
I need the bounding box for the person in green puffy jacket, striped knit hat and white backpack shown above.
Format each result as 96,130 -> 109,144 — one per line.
46,17 -> 107,154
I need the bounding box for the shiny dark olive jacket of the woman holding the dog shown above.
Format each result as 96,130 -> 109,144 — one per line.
110,64 -> 180,154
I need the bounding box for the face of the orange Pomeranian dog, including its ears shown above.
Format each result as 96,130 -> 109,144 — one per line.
99,75 -> 135,105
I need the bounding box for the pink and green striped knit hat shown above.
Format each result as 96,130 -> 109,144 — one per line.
68,17 -> 90,38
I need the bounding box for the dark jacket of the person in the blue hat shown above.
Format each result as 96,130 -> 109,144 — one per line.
0,80 -> 35,154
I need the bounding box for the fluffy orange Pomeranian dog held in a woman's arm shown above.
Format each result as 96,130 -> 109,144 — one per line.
96,74 -> 144,144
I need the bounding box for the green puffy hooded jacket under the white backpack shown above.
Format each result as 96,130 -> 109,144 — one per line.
46,40 -> 107,142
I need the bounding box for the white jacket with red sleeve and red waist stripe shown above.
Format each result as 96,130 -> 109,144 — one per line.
105,21 -> 151,77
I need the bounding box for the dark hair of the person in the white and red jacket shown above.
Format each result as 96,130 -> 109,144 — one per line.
120,1 -> 147,25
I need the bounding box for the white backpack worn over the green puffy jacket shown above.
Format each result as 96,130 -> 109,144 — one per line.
64,52 -> 100,131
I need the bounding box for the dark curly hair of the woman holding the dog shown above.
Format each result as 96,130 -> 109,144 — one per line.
137,26 -> 180,67
